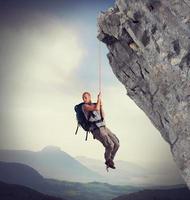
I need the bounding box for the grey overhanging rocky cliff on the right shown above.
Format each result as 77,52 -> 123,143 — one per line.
98,0 -> 190,188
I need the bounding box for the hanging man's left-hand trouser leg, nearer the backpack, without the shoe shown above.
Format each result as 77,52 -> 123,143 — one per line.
93,127 -> 114,161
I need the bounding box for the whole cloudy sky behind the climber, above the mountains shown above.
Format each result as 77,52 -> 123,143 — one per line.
0,0 -> 183,180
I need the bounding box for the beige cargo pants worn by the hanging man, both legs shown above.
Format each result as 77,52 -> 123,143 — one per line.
92,126 -> 120,161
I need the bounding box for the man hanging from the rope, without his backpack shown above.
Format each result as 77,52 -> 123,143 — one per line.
82,92 -> 120,169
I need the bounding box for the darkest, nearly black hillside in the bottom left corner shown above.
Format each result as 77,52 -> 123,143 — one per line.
0,181 -> 63,200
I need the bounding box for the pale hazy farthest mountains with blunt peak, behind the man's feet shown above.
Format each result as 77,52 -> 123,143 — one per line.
0,146 -> 184,187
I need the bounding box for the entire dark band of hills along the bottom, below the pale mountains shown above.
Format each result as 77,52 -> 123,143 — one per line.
0,155 -> 190,200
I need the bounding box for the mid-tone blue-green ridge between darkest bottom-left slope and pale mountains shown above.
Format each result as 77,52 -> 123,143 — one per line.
0,161 -> 138,200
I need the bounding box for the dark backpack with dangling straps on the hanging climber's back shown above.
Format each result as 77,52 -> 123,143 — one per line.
74,102 -> 92,140
